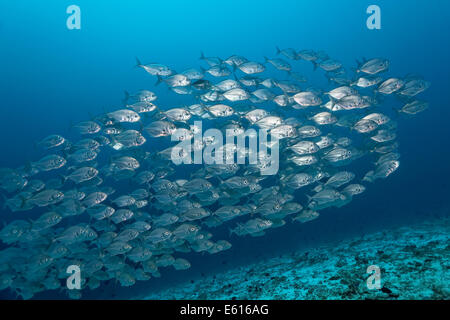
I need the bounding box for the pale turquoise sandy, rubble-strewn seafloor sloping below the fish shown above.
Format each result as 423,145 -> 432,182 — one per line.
138,218 -> 450,300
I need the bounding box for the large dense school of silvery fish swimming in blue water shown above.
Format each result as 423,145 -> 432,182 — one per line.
0,48 -> 430,299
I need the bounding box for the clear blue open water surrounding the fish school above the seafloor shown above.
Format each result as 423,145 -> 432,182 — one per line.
0,0 -> 450,298
